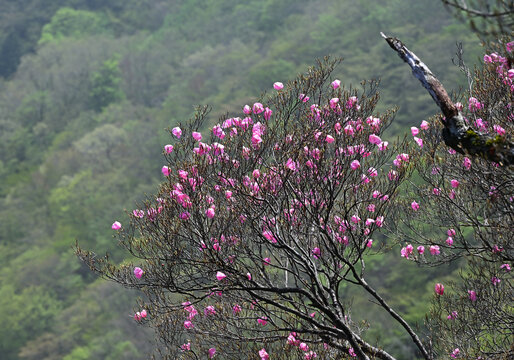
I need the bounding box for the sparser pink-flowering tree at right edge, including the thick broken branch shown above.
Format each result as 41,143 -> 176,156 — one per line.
386,33 -> 514,359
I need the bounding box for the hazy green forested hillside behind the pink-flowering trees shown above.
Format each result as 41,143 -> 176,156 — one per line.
0,0 -> 483,360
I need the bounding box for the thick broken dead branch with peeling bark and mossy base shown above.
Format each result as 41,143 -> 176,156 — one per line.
380,33 -> 514,166
